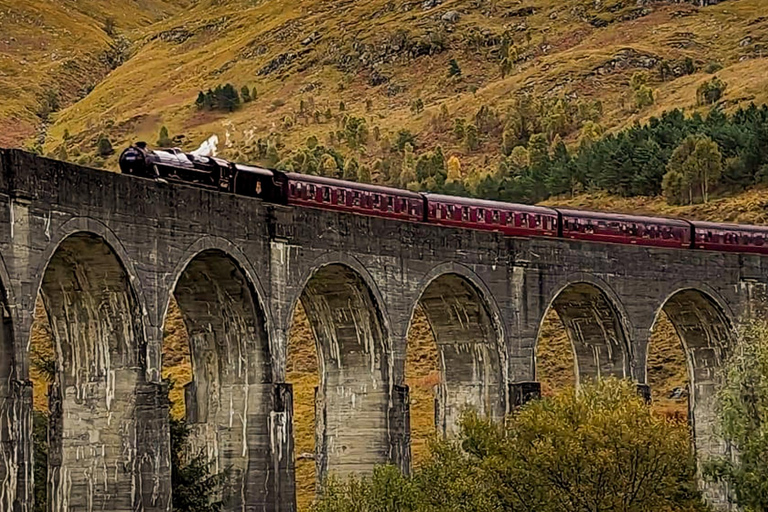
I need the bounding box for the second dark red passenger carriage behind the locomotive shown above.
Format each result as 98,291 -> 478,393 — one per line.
426,194 -> 557,236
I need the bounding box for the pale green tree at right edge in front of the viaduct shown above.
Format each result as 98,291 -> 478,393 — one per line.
704,321 -> 768,512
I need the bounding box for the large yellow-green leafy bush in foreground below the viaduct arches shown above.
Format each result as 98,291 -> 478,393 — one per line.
315,380 -> 705,512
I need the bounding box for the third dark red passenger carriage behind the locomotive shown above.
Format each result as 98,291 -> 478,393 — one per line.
558,209 -> 692,248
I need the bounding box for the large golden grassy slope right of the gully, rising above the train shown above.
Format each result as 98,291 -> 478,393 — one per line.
30,0 -> 768,174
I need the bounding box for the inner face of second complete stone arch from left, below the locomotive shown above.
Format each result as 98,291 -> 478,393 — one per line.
166,247 -> 275,510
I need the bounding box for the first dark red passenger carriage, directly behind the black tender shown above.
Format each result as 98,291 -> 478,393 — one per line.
286,173 -> 424,222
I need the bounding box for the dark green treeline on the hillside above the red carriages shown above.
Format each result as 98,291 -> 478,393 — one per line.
462,105 -> 768,203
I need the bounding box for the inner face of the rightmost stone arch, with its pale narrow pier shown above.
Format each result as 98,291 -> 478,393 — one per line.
646,285 -> 734,470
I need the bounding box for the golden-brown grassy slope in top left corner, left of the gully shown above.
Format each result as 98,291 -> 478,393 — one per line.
0,0 -> 187,146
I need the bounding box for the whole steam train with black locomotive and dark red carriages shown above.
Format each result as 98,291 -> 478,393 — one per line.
120,143 -> 768,254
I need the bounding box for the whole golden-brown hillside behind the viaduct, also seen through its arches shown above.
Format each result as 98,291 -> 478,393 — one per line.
10,0 -> 768,509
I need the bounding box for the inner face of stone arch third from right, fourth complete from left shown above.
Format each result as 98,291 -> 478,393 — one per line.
411,263 -> 506,434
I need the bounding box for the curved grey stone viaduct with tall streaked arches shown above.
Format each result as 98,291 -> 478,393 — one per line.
0,146 -> 768,512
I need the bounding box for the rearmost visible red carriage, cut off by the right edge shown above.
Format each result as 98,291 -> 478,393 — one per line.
692,222 -> 768,254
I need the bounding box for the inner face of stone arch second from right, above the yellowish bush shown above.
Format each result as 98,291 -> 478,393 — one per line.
539,276 -> 631,386
